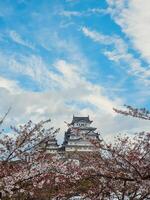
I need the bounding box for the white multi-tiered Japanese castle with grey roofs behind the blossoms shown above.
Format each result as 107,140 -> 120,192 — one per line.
40,116 -> 99,153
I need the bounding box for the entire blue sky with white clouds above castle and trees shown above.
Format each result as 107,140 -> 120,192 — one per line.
0,0 -> 150,143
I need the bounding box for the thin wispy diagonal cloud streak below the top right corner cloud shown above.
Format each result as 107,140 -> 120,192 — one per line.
82,27 -> 150,85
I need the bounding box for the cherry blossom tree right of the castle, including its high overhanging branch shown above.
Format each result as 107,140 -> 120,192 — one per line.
60,106 -> 150,200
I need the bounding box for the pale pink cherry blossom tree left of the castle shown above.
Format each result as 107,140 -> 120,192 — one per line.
0,119 -> 63,199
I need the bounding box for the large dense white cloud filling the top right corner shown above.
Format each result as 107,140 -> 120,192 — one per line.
107,0 -> 150,63
